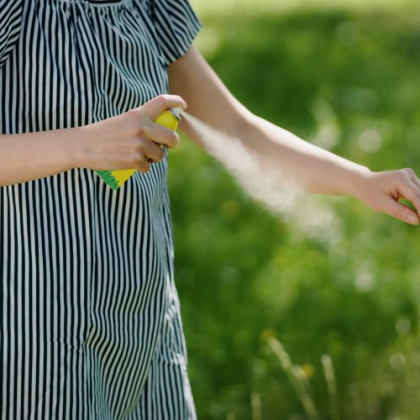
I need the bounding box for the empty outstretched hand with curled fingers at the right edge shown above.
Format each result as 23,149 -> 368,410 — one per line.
357,168 -> 420,225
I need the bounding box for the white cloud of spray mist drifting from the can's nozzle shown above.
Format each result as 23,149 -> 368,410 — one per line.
183,113 -> 342,244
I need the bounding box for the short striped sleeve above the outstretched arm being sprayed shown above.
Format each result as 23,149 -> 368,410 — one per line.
149,0 -> 202,65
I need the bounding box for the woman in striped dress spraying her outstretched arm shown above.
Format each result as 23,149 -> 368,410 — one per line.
0,0 -> 420,420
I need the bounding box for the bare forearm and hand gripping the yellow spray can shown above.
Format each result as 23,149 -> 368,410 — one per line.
0,95 -> 186,186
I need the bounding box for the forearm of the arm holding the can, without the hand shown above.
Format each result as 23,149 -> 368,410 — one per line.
0,128 -> 85,186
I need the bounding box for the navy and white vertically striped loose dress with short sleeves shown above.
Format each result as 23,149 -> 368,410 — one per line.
0,0 -> 200,420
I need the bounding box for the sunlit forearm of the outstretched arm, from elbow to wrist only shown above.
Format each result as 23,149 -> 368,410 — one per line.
238,116 -> 370,196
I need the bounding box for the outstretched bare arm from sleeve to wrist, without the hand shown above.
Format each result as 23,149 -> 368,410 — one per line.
169,48 -> 369,195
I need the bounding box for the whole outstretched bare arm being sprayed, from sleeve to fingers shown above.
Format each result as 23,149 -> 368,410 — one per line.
168,47 -> 420,224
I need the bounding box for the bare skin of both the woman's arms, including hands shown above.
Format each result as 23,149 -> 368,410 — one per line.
0,46 -> 420,225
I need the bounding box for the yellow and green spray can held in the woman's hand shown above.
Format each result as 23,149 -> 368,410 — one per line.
95,108 -> 182,190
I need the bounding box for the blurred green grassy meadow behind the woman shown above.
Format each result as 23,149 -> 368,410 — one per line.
168,0 -> 420,420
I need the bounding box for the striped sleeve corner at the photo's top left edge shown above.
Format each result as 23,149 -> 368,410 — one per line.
0,0 -> 23,68
